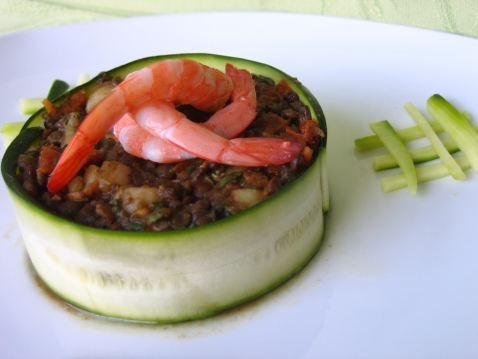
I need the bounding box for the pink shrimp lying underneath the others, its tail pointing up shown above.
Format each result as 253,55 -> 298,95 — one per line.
114,64 -> 257,163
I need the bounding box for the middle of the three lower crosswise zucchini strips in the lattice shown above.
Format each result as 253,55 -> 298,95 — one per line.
373,125 -> 478,171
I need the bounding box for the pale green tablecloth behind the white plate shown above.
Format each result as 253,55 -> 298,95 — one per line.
0,0 -> 478,38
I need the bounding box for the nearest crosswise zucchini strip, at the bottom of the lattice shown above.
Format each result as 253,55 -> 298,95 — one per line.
382,156 -> 471,193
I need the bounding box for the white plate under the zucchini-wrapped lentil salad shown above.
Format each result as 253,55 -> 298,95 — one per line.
0,13 -> 478,359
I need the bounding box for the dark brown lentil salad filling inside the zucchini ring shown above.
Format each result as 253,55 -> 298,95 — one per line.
17,75 -> 324,231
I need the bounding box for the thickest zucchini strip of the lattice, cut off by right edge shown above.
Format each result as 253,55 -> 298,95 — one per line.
427,94 -> 478,172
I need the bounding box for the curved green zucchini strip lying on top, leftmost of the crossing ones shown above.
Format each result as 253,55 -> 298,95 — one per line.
369,121 -> 417,194
